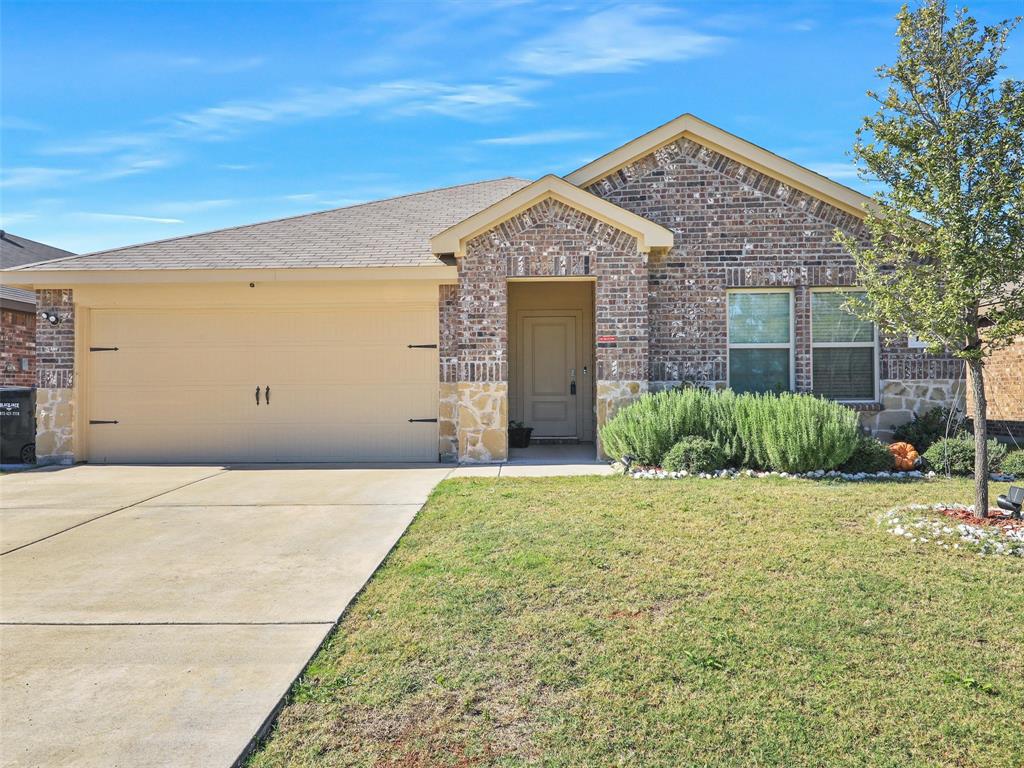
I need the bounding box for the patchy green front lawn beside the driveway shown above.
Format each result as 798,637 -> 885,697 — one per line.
251,477 -> 1024,768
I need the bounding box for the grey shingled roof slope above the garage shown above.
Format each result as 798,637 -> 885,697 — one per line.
8,177 -> 529,272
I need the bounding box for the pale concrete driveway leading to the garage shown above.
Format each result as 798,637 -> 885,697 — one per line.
0,465 -> 451,768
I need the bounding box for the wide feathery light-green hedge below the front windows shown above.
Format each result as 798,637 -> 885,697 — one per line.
601,388 -> 860,472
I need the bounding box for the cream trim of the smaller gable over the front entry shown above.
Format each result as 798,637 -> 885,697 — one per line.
430,174 -> 673,257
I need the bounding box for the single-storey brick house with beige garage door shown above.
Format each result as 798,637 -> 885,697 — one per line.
9,115 -> 964,462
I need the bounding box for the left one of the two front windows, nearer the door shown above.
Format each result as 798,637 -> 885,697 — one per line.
728,291 -> 793,392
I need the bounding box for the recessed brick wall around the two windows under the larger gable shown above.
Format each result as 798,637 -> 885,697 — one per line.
588,138 -> 963,433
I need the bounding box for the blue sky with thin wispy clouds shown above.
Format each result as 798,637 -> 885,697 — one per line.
0,0 -> 1024,252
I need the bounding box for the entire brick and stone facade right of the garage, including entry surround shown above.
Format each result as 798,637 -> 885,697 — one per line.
440,138 -> 964,460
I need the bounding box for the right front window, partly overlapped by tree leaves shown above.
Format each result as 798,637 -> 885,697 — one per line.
811,291 -> 878,400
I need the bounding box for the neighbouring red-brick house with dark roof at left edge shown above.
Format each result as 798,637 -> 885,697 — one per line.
0,229 -> 74,387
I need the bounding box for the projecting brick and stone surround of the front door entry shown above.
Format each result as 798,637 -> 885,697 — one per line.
454,200 -> 648,461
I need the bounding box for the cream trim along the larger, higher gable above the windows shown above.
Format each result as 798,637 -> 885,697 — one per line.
565,113 -> 878,217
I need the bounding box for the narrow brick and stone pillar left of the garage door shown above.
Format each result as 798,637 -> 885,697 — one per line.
36,289 -> 75,464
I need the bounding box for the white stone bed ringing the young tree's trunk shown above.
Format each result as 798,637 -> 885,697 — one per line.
879,504 -> 1024,557
